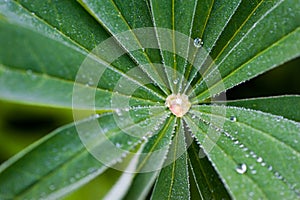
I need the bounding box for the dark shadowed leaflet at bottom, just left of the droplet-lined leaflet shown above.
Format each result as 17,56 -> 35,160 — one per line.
188,142 -> 230,199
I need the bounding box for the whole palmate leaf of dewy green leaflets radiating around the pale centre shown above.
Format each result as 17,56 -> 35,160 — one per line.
0,0 -> 300,199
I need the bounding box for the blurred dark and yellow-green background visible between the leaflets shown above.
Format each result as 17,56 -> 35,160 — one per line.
0,58 -> 300,200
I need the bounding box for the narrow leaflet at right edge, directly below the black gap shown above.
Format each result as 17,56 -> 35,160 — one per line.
226,95 -> 300,122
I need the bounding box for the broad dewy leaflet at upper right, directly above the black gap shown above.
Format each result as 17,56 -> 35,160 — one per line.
193,0 -> 300,103
